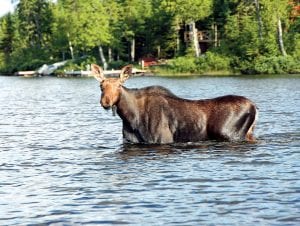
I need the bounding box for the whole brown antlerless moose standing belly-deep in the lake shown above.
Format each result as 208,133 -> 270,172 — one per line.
91,64 -> 257,144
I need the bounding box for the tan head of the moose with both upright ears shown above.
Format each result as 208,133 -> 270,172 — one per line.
91,64 -> 132,109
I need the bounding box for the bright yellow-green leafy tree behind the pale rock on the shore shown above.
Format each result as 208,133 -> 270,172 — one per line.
58,0 -> 109,61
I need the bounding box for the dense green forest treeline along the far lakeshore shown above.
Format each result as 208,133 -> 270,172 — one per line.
0,0 -> 300,73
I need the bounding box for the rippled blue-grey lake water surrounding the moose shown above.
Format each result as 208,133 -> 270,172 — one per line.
0,76 -> 300,225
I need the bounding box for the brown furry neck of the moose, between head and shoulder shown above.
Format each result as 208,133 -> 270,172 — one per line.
116,87 -> 139,125
